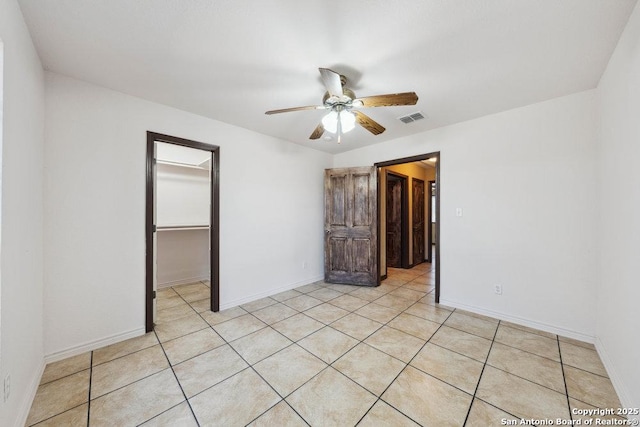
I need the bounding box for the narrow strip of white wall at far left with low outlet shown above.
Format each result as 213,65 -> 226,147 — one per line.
0,0 -> 44,426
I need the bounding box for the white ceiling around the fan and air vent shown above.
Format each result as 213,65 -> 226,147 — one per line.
19,0 -> 636,153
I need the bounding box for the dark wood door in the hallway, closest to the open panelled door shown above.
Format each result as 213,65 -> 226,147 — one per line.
385,174 -> 402,268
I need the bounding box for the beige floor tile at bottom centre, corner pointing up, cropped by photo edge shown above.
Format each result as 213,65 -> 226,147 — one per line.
287,367 -> 376,426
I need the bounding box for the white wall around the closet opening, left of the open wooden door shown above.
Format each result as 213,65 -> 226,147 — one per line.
44,73 -> 331,359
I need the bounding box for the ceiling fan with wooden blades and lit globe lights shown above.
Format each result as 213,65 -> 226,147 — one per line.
265,68 -> 418,143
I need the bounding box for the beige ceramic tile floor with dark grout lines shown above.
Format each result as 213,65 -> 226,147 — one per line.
27,264 -> 620,427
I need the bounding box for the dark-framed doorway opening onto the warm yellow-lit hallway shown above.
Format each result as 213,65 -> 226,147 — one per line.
375,152 -> 440,302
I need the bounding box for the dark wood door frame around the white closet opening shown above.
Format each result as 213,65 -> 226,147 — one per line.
145,131 -> 220,332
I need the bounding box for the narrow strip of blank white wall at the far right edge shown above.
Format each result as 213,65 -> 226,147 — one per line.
596,0 -> 640,414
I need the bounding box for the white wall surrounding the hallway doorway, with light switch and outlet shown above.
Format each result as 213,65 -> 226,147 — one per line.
334,91 -> 597,341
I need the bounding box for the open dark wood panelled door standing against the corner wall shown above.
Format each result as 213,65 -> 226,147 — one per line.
324,167 -> 380,286
